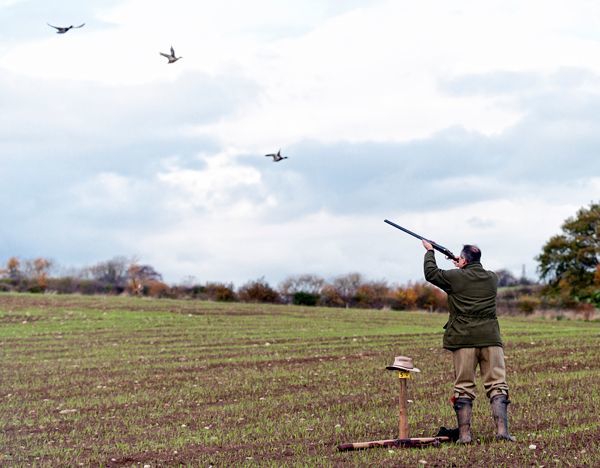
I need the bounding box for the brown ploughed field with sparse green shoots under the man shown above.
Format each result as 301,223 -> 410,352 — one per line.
0,294 -> 600,466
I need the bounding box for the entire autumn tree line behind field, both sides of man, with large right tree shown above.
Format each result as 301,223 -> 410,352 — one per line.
0,203 -> 600,313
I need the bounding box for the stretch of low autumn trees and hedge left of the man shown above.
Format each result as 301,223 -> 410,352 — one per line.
0,257 -> 446,311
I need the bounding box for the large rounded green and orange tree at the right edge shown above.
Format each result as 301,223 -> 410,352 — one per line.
536,203 -> 600,308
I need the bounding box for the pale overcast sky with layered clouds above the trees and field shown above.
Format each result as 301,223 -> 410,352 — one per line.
0,0 -> 600,285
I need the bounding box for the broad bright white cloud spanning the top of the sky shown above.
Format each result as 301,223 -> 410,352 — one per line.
3,0 -> 600,145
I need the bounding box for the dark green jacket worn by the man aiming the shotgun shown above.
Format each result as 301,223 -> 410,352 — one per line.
424,250 -> 502,350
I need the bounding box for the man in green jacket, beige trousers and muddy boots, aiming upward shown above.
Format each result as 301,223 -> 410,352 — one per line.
423,240 -> 516,443
